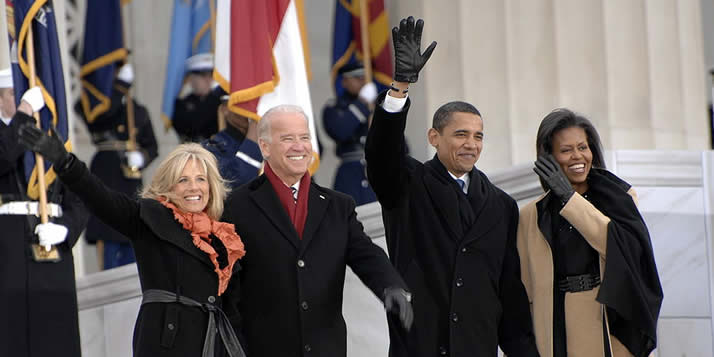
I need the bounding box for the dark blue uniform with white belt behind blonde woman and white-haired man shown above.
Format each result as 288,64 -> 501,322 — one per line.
201,124 -> 263,189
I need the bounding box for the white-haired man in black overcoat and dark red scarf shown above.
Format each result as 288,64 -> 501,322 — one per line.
223,106 -> 412,357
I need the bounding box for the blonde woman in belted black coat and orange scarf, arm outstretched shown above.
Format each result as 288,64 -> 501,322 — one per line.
18,106 -> 245,357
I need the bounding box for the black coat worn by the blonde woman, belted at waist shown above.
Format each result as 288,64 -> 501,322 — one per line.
59,157 -> 239,357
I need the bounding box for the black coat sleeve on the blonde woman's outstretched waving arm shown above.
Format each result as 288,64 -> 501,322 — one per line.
57,154 -> 141,240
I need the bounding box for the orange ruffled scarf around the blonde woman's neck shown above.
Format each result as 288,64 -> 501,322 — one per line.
159,199 -> 245,296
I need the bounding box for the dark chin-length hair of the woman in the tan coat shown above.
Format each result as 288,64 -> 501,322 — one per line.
536,108 -> 605,190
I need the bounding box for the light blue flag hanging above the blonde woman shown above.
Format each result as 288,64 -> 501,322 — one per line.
161,0 -> 216,129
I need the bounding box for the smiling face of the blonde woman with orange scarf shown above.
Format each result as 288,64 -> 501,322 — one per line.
171,160 -> 210,213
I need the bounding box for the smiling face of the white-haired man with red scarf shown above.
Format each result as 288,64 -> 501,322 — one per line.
258,112 -> 312,186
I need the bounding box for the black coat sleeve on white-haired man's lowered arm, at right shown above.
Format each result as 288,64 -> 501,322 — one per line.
346,199 -> 408,300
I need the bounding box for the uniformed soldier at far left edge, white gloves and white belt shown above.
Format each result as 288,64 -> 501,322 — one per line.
0,73 -> 88,357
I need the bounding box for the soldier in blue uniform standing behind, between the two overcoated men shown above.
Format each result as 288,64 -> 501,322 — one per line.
322,64 -> 377,206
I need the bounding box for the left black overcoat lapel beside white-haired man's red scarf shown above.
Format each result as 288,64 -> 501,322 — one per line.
250,178 -> 298,249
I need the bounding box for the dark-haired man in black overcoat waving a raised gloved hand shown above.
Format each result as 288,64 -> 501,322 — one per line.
366,17 -> 538,357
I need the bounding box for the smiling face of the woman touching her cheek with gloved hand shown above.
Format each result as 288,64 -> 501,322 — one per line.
552,126 -> 593,194
